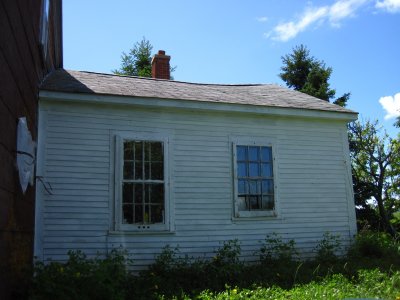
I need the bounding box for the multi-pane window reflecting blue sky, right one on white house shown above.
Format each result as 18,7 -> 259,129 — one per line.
234,142 -> 276,217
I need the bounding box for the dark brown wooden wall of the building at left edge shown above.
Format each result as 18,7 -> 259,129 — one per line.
0,0 -> 62,299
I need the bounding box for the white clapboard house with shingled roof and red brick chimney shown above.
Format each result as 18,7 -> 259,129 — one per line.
34,51 -> 357,268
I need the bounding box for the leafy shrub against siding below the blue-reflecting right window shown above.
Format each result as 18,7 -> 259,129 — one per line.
259,233 -> 298,264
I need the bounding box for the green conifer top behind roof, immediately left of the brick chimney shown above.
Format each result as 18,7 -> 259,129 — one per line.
112,37 -> 153,77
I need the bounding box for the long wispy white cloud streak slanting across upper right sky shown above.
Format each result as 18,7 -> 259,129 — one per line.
265,0 -> 368,42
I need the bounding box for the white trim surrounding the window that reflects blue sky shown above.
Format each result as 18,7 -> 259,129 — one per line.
231,137 -> 279,220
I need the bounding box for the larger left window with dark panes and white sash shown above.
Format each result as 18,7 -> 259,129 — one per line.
116,137 -> 168,230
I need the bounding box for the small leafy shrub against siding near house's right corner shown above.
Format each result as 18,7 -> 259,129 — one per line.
314,231 -> 342,264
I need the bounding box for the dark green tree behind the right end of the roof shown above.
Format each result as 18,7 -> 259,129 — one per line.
279,45 -> 350,106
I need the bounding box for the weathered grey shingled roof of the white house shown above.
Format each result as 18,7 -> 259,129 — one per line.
41,69 -> 355,114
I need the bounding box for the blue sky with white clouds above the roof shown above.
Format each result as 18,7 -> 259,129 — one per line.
63,0 -> 400,136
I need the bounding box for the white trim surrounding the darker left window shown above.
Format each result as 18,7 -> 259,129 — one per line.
114,133 -> 172,233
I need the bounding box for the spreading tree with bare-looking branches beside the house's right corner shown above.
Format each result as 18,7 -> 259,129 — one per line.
349,121 -> 400,236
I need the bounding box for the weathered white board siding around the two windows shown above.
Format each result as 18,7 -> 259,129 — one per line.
36,101 -> 355,268
